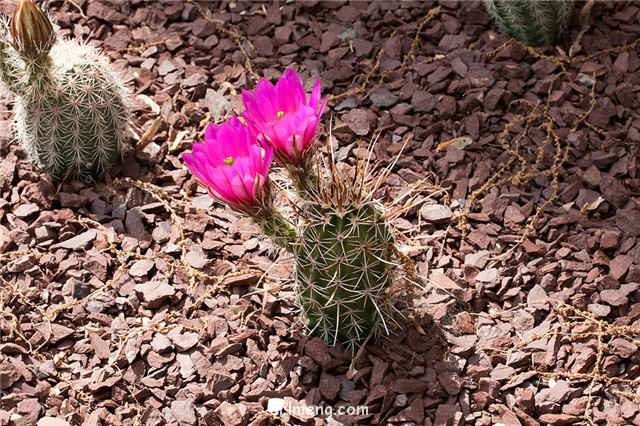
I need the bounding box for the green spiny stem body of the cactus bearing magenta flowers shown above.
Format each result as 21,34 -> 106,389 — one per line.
294,204 -> 394,347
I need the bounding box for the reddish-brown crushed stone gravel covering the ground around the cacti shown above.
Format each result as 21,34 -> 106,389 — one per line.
0,0 -> 640,426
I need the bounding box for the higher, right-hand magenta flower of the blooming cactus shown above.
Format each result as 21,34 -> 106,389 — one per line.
242,68 -> 327,166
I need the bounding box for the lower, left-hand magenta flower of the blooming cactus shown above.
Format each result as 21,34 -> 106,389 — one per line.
182,117 -> 273,214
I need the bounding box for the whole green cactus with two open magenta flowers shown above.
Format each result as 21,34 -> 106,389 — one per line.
183,69 -> 404,348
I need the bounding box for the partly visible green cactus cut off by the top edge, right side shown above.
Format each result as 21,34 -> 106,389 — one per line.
484,0 -> 574,46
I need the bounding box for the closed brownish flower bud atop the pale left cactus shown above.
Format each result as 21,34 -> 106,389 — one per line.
9,0 -> 55,59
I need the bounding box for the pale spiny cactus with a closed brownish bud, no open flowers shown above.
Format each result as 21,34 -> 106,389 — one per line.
0,0 -> 130,179
